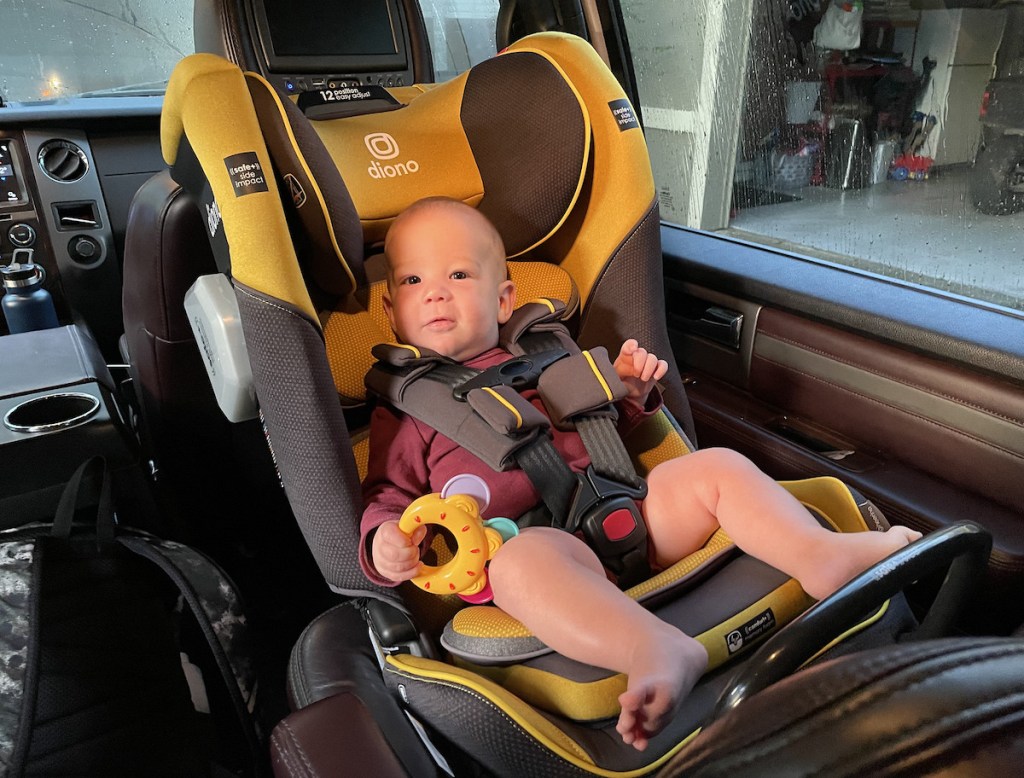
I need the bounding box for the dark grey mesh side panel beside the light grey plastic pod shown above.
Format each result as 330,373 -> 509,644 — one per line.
236,283 -> 393,597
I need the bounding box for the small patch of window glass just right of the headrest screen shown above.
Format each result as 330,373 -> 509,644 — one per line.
420,0 -> 498,81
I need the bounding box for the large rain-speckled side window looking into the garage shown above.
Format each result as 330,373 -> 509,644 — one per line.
621,0 -> 1024,310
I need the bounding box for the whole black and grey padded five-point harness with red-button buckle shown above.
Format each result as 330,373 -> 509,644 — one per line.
367,300 -> 647,586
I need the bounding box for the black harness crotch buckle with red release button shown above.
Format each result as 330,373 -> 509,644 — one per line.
565,465 -> 650,589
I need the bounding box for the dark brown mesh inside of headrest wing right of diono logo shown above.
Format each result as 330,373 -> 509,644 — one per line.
461,52 -> 587,256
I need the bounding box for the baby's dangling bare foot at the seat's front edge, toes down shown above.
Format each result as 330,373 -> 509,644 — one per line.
615,630 -> 708,751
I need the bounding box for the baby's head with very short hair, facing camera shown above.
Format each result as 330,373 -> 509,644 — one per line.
384,198 -> 515,361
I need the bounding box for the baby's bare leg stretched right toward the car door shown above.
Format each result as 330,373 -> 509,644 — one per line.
643,448 -> 921,599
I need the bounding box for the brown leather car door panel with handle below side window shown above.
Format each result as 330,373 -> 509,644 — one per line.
664,227 -> 1024,630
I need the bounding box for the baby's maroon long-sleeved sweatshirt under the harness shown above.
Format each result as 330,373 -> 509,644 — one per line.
359,347 -> 662,587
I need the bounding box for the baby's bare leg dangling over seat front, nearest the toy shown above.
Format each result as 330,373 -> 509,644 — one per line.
487,527 -> 708,750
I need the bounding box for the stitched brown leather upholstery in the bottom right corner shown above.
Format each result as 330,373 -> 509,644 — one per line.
662,638 -> 1024,778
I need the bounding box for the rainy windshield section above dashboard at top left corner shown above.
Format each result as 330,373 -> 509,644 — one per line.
0,0 -> 194,102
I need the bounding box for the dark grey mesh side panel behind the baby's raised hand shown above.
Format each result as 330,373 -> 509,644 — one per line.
578,202 -> 696,444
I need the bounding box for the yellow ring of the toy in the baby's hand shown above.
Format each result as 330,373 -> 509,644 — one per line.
398,493 -> 503,597
